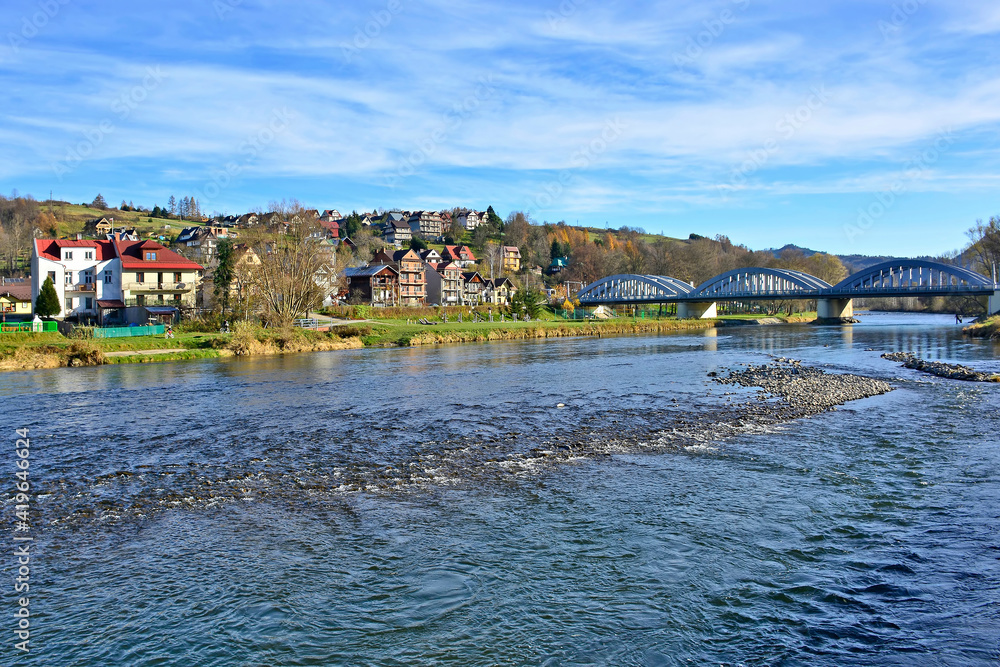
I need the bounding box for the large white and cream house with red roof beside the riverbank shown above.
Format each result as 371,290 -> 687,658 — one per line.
31,239 -> 204,323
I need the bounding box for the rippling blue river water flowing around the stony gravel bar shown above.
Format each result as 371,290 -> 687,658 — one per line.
0,314 -> 1000,667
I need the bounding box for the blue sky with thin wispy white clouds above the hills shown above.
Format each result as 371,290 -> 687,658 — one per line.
0,0 -> 1000,255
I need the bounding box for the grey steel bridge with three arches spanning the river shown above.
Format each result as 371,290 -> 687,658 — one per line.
579,259 -> 1000,312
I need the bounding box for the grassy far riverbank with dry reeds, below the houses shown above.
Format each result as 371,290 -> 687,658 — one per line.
0,317 -> 807,371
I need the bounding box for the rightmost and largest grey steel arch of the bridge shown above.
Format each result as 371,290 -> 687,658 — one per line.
833,259 -> 994,294
